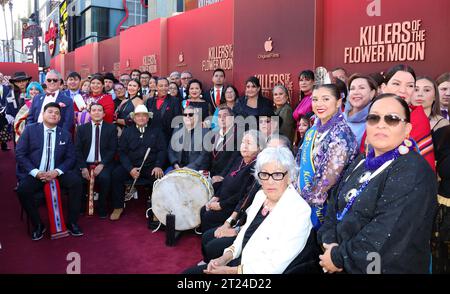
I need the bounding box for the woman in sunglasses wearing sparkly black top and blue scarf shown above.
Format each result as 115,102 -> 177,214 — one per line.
318,94 -> 437,274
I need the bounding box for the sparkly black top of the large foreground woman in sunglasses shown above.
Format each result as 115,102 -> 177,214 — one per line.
318,151 -> 437,274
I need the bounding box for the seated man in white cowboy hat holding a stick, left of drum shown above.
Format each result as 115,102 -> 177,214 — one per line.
110,105 -> 167,220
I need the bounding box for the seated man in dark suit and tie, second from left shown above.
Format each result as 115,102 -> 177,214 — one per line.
75,104 -> 117,218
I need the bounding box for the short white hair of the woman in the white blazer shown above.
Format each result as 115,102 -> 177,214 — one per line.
254,147 -> 298,183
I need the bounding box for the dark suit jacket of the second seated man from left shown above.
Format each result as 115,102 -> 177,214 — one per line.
75,122 -> 117,169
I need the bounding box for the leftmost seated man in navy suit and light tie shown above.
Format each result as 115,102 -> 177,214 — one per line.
16,102 -> 83,240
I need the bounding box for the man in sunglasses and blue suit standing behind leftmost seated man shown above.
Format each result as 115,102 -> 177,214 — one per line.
27,70 -> 74,132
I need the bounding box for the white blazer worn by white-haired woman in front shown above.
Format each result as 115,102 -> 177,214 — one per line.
224,185 -> 312,274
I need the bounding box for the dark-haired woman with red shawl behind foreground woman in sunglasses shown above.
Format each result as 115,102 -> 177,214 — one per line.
381,64 -> 436,170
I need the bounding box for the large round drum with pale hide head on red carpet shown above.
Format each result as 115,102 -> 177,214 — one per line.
152,168 -> 214,231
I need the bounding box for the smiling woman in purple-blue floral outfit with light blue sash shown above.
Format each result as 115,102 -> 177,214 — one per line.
297,84 -> 357,229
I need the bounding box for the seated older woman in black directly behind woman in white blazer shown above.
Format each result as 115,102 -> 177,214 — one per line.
200,130 -> 266,232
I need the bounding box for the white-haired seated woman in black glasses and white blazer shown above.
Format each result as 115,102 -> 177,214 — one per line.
185,147 -> 312,274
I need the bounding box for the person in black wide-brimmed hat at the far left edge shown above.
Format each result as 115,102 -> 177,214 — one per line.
0,71 -> 31,150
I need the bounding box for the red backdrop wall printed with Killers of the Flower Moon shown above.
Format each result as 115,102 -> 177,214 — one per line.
46,0 -> 450,99
